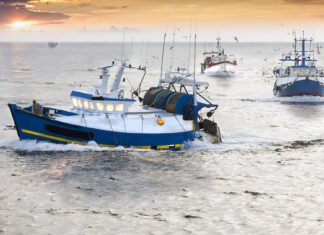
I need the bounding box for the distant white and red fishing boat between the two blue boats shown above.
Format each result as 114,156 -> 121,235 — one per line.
201,38 -> 237,77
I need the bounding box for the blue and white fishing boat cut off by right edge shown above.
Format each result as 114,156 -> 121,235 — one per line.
273,33 -> 324,97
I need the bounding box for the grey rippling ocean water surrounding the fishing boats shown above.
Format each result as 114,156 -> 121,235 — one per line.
0,43 -> 324,234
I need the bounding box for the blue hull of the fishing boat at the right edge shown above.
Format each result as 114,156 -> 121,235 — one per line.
274,79 -> 324,97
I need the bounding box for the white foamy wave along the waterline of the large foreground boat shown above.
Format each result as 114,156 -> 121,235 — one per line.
0,134 -> 324,153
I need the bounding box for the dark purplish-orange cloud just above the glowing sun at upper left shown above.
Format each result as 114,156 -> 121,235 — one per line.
0,0 -> 70,25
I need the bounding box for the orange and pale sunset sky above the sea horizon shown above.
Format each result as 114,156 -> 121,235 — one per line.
0,0 -> 324,42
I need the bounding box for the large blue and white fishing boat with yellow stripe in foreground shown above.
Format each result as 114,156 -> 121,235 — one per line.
8,34 -> 221,150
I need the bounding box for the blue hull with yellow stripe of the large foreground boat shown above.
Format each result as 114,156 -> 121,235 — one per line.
8,104 -> 197,149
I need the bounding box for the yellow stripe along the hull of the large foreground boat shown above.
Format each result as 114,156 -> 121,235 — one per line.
21,129 -> 183,150
